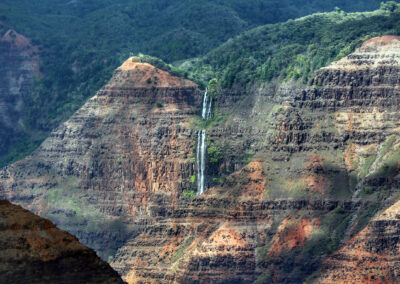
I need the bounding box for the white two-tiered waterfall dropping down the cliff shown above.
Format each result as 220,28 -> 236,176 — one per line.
196,89 -> 212,195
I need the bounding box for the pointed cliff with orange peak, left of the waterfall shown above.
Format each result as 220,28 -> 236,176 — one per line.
0,59 -> 201,257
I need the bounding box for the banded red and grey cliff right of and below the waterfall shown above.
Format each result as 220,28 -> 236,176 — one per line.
112,37 -> 400,283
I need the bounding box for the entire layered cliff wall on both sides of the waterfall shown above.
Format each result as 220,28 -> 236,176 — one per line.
0,37 -> 400,283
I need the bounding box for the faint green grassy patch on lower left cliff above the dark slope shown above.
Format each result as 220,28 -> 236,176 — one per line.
35,176 -> 131,259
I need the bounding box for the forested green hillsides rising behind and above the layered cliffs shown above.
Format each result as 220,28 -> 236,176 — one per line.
0,0 -> 399,166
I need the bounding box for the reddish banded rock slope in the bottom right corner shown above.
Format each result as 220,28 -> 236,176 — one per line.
318,201 -> 400,284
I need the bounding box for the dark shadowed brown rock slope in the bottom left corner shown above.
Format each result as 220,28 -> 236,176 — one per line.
0,200 -> 123,283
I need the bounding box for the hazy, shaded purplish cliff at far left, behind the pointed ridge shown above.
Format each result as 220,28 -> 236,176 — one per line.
0,28 -> 39,158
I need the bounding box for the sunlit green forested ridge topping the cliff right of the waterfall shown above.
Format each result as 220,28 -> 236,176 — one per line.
182,2 -> 400,88
